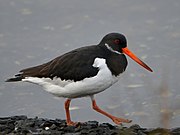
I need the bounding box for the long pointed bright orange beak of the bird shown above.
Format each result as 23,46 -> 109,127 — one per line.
122,47 -> 153,72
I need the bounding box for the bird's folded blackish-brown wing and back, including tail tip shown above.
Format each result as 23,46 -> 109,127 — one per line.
7,46 -> 103,82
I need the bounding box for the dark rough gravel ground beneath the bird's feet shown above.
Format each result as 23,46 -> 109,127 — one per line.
0,115 -> 180,135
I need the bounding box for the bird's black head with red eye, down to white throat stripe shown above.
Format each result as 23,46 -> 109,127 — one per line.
100,33 -> 127,53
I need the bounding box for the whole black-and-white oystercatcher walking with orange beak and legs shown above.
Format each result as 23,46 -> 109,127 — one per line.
7,33 -> 152,125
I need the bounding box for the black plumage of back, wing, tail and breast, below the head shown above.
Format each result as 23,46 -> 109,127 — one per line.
7,44 -> 127,82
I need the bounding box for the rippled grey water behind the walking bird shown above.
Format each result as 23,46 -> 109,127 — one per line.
0,0 -> 180,127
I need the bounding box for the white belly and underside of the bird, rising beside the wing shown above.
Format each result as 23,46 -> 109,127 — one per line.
22,58 -> 121,98
